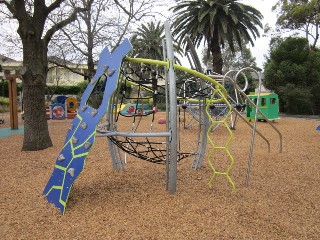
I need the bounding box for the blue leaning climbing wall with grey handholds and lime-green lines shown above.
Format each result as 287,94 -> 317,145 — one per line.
43,40 -> 132,213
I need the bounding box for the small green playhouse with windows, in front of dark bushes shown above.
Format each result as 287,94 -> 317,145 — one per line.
246,93 -> 279,121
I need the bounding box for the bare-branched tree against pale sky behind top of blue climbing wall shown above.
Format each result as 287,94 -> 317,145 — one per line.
50,0 -> 155,79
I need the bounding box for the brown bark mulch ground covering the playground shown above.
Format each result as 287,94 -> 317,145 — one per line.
0,113 -> 320,239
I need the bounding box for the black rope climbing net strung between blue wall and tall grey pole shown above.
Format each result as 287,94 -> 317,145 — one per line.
100,62 -> 196,164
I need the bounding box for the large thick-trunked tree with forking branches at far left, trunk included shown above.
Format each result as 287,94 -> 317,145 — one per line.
0,0 -> 92,151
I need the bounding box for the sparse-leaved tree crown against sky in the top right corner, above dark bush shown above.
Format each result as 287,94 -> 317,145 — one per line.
272,0 -> 320,48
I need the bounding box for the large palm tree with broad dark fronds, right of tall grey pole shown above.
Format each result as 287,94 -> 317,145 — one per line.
171,0 -> 262,74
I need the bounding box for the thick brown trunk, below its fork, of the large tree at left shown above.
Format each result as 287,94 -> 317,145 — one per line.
22,36 -> 52,151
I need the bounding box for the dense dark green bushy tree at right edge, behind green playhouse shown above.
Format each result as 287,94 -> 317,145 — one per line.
264,37 -> 320,114
